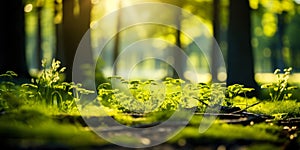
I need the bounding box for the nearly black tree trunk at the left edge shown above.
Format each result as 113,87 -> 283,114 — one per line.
0,0 -> 30,80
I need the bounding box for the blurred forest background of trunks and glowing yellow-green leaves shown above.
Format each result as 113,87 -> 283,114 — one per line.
0,0 -> 300,87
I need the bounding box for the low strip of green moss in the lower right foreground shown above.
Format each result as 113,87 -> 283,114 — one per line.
169,123 -> 285,144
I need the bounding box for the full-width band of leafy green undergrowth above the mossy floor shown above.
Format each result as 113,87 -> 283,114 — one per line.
0,62 -> 299,116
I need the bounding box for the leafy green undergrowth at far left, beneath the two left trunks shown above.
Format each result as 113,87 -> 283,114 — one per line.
0,59 -> 92,112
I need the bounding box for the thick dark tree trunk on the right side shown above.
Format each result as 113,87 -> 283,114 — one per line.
227,0 -> 258,89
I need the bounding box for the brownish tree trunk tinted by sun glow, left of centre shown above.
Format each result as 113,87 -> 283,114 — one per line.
62,0 -> 93,81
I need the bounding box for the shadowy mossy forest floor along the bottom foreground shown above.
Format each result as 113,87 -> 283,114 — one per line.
0,101 -> 300,150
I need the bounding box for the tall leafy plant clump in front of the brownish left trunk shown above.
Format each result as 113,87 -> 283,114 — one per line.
22,59 -> 92,111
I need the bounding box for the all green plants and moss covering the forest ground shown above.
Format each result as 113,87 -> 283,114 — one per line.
0,60 -> 300,149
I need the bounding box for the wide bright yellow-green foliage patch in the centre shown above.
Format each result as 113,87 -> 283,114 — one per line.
97,77 -> 254,114
